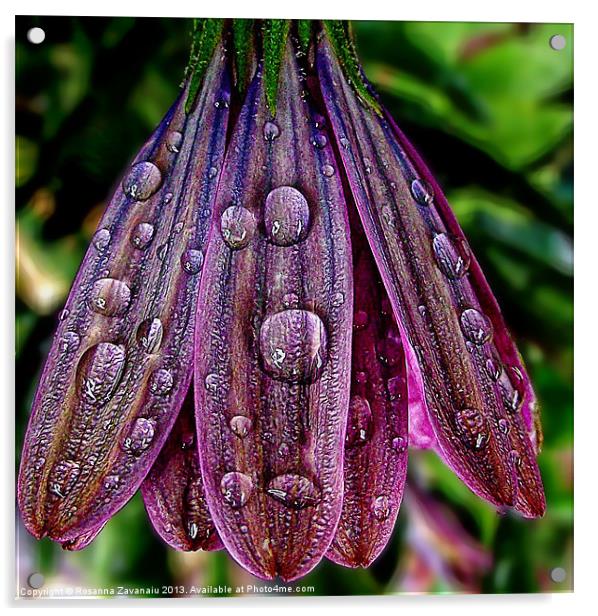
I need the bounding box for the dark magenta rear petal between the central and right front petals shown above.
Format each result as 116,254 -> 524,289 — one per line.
327,206 -> 408,567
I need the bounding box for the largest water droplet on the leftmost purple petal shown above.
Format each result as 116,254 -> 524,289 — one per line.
77,342 -> 126,406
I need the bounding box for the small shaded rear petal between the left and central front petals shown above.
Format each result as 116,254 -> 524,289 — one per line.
141,390 -> 222,552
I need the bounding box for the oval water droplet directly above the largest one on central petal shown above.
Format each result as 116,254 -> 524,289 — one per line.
264,186 -> 310,246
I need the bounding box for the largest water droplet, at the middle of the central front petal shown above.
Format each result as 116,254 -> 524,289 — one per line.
260,309 -> 328,383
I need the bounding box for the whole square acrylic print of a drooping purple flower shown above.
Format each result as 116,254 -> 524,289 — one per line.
15,16 -> 573,599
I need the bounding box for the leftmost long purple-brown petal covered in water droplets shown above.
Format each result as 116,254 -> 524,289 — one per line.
18,45 -> 229,542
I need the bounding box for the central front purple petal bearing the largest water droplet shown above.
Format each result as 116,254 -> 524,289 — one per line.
195,41 -> 353,580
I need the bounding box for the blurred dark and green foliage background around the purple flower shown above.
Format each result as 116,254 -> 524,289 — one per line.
16,17 -> 573,596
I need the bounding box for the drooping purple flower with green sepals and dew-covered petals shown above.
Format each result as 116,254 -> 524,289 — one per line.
18,20 -> 545,580
